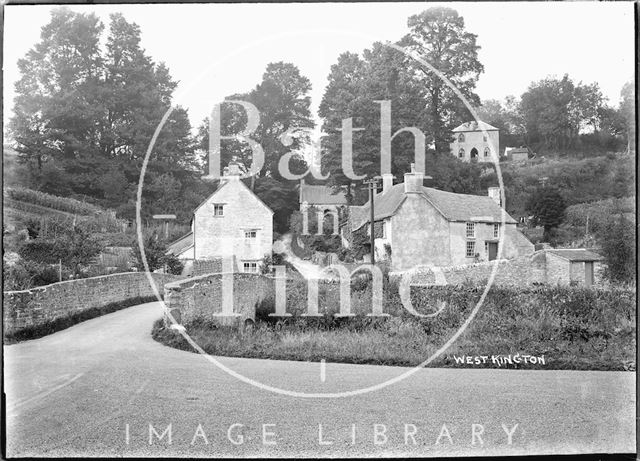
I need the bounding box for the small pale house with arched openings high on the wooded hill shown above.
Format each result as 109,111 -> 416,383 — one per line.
449,121 -> 500,163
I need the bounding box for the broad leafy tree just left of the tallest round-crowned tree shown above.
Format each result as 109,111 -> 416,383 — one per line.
319,42 -> 432,200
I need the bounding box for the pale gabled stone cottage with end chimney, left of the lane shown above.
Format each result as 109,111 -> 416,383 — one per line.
167,162 -> 273,272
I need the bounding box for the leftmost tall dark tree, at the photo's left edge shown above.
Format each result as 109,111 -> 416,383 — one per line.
9,8 -> 103,185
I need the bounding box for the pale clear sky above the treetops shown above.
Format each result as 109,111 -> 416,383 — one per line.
3,2 -> 635,138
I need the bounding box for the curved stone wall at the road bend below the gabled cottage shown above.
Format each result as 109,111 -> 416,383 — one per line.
164,273 -> 275,325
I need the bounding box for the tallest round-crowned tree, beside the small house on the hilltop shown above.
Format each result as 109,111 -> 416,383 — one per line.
400,7 -> 484,153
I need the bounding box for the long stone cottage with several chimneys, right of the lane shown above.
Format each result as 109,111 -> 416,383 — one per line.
341,165 -> 534,271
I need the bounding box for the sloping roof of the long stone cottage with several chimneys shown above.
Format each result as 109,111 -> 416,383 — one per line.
352,183 -> 516,230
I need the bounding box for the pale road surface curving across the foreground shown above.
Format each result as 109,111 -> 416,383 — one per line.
4,303 -> 635,457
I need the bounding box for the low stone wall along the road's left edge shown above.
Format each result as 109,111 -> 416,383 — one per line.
3,272 -> 179,334
